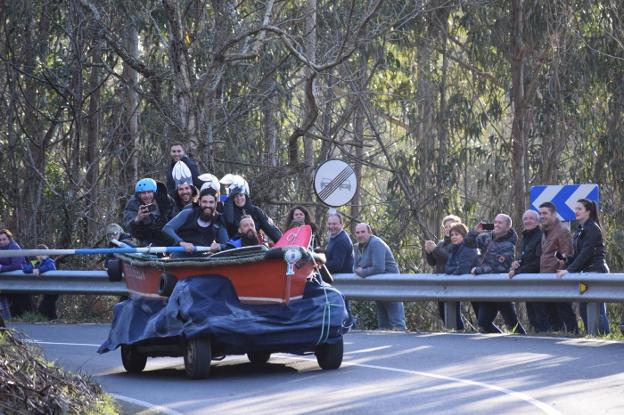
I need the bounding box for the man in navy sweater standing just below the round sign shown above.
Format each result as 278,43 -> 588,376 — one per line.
325,212 -> 353,274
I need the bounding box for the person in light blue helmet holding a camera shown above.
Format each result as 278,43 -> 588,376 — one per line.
122,178 -> 177,246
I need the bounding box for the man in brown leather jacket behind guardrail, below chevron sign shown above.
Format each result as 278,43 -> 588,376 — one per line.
533,202 -> 578,333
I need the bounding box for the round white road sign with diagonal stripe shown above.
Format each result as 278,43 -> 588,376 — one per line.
314,160 -> 357,207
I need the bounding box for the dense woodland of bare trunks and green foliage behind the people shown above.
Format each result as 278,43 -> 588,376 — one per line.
0,0 -> 624,334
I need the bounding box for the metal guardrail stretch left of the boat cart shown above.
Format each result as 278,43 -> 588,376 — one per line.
0,271 -> 128,295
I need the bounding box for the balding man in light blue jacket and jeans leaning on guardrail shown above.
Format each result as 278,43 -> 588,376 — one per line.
353,223 -> 406,330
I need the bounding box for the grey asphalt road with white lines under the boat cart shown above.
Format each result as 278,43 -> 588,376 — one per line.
12,324 -> 624,414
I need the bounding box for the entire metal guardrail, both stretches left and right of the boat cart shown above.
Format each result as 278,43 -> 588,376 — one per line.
0,270 -> 624,334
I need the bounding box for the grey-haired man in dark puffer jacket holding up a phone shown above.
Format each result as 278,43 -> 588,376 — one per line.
465,213 -> 526,334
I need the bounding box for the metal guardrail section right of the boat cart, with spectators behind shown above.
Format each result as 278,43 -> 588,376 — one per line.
333,273 -> 624,335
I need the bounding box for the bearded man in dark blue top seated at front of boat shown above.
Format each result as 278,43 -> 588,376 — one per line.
163,189 -> 228,258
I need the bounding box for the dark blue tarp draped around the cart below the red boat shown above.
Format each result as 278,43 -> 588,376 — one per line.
98,276 -> 350,354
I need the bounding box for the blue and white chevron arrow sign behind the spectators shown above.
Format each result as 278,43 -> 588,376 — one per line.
530,184 -> 600,221
